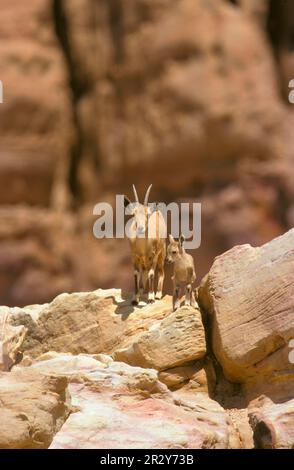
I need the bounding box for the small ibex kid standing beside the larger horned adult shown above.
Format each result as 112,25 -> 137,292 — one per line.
166,235 -> 197,310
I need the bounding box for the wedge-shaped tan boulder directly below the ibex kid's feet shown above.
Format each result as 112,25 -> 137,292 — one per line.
114,307 -> 206,370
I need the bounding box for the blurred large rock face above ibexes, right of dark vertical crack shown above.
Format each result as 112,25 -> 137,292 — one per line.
59,0 -> 283,192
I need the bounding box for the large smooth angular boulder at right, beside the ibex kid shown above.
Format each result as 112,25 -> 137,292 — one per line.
199,230 -> 294,395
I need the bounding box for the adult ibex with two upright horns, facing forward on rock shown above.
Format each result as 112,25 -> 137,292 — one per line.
125,184 -> 166,305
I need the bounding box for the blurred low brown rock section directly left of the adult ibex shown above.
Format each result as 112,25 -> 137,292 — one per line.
0,206 -> 131,306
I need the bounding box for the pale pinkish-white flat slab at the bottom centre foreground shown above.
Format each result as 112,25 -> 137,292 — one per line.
25,353 -> 239,449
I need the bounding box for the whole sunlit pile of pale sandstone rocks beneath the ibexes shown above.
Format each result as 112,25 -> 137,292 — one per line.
0,230 -> 294,449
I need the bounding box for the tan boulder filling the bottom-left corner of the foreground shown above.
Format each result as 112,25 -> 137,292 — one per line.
0,368 -> 69,449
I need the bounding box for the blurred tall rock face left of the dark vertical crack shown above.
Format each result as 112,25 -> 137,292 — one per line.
0,0 -> 71,206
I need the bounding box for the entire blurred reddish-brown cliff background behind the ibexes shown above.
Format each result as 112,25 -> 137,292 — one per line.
0,0 -> 294,305
